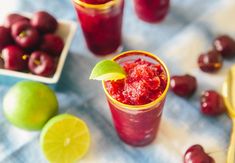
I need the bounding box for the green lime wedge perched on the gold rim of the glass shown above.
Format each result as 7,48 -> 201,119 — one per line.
90,60 -> 126,80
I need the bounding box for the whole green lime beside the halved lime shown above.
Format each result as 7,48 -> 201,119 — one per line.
3,81 -> 58,130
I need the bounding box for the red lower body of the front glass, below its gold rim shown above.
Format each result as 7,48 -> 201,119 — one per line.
108,101 -> 164,146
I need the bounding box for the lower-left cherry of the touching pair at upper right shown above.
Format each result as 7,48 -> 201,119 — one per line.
198,50 -> 223,72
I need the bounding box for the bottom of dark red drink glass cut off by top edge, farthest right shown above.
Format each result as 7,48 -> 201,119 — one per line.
134,0 -> 170,23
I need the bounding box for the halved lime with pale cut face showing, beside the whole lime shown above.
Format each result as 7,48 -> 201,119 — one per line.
40,114 -> 90,163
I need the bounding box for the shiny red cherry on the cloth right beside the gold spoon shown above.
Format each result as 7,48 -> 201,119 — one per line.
201,90 -> 226,116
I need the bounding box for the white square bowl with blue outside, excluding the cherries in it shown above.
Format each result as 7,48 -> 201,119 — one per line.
0,14 -> 77,85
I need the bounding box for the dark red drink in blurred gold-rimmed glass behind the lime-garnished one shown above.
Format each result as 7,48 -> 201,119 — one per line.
75,0 -> 124,55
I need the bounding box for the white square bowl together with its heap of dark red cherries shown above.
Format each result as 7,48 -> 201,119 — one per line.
0,11 -> 77,84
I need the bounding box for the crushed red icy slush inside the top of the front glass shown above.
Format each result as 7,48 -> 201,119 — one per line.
106,59 -> 167,105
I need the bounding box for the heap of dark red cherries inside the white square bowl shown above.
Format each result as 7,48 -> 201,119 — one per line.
0,11 -> 64,77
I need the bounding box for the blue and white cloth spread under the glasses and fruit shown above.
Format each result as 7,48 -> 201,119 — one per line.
0,0 -> 235,163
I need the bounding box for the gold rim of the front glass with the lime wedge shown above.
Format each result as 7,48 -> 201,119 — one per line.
102,50 -> 170,110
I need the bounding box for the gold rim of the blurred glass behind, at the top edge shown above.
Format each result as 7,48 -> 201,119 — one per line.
73,0 -> 121,10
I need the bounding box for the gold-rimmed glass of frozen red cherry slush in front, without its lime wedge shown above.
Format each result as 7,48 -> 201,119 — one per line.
103,51 -> 170,146
